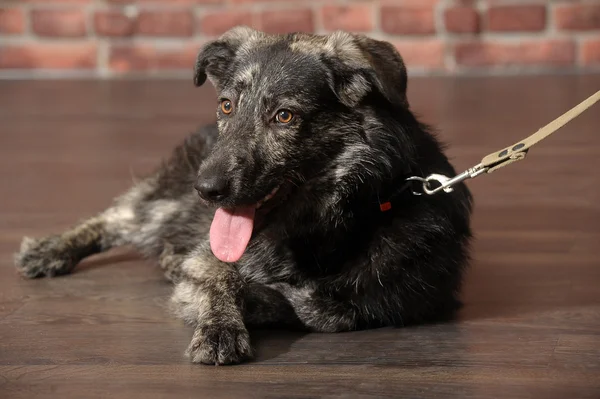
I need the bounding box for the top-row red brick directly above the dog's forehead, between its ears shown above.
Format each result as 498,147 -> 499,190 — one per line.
258,9 -> 315,33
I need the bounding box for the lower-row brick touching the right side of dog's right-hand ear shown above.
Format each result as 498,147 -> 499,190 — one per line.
393,39 -> 445,70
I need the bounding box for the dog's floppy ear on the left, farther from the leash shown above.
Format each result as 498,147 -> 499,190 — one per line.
194,26 -> 264,89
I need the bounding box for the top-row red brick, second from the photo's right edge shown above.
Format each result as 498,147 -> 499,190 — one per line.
487,4 -> 546,32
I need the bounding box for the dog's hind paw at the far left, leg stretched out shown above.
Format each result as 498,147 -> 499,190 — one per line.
14,236 -> 75,278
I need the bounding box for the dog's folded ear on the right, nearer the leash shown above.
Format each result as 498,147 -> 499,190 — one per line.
328,32 -> 408,107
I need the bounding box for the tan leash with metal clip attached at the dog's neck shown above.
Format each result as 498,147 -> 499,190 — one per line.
406,90 -> 600,195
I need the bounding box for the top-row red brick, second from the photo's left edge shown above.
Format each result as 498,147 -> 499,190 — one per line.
31,9 -> 86,37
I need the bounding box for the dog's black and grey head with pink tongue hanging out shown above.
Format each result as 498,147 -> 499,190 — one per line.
194,27 -> 408,261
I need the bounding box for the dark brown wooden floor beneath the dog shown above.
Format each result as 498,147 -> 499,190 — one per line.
0,76 -> 600,399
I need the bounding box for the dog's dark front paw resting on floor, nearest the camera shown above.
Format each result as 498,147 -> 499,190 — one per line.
187,323 -> 253,365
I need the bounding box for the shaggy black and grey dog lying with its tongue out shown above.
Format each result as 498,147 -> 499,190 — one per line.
15,27 -> 473,365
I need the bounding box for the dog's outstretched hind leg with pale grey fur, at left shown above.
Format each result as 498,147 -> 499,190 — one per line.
15,126 -> 218,280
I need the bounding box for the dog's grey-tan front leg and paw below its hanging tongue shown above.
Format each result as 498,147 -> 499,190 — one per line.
171,246 -> 252,364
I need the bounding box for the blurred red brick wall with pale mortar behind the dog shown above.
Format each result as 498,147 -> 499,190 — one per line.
0,0 -> 600,77
